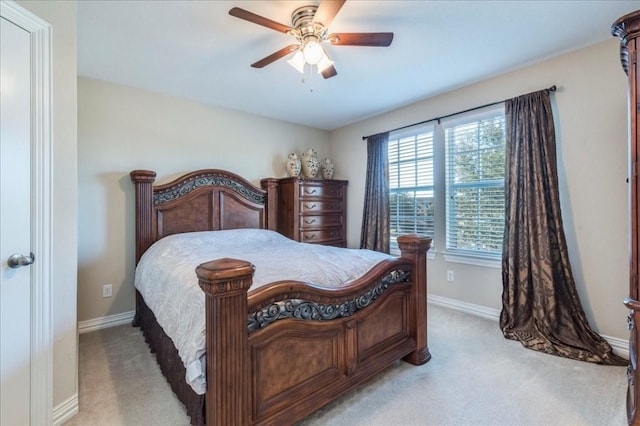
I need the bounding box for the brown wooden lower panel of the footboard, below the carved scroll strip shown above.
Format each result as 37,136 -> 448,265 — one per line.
249,276 -> 416,424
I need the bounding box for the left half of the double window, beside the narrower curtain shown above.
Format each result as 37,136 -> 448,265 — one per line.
389,126 -> 434,254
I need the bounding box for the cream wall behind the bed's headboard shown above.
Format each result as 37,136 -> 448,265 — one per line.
78,77 -> 329,321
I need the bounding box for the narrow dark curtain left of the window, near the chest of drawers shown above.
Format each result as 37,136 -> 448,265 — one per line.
360,132 -> 390,253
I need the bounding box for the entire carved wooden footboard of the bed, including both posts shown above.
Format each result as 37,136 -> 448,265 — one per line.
196,235 -> 431,425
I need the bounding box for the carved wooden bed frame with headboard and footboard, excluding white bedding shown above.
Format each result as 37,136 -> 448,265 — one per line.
130,169 -> 431,426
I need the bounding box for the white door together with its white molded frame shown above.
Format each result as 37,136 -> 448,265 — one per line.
0,1 -> 52,425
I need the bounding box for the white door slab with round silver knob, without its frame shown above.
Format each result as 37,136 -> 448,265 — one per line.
0,13 -> 32,425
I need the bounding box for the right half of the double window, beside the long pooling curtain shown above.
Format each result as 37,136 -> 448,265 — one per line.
444,108 -> 505,257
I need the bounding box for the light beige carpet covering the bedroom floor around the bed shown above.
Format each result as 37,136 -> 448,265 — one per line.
66,305 -> 626,426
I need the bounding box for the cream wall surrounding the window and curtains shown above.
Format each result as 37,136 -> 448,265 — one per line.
331,38 -> 629,340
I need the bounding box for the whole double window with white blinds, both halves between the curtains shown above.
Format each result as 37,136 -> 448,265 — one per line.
388,105 -> 505,266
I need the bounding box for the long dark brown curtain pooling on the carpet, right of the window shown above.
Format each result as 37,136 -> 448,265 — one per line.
500,90 -> 628,365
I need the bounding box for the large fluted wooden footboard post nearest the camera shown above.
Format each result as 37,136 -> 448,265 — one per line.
196,259 -> 255,426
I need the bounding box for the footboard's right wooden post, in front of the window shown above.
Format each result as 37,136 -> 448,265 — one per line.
398,234 -> 431,365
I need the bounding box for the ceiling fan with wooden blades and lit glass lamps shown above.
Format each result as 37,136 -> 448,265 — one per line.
229,0 -> 393,78
